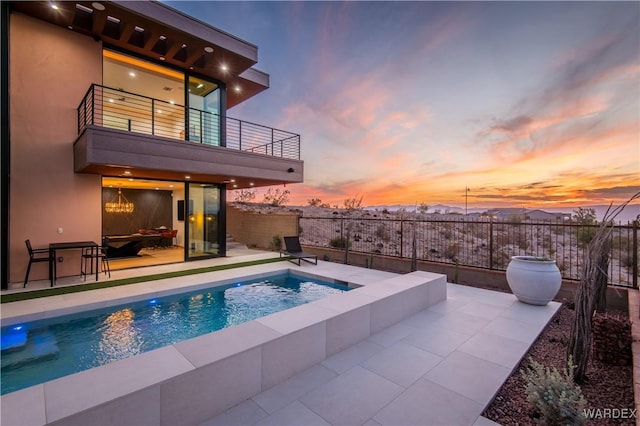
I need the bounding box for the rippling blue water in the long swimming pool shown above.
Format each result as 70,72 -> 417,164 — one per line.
0,274 -> 349,394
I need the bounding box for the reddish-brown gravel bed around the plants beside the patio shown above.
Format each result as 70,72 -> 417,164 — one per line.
483,304 -> 635,426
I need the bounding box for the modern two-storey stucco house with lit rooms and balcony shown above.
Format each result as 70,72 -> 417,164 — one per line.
1,1 -> 303,288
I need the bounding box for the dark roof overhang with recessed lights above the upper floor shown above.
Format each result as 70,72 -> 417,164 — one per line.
12,1 -> 269,108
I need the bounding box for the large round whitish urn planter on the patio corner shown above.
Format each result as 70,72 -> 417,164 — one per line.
507,256 -> 562,305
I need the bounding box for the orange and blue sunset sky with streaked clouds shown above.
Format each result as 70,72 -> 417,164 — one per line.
167,1 -> 640,208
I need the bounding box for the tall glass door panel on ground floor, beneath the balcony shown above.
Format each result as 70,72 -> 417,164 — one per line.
187,183 -> 220,259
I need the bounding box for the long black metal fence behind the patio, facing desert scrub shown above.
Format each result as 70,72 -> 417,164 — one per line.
300,217 -> 639,288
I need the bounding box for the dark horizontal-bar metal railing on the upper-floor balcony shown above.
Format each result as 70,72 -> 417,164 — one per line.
78,84 -> 300,160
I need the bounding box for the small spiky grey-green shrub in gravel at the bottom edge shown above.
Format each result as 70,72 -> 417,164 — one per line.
520,358 -> 587,425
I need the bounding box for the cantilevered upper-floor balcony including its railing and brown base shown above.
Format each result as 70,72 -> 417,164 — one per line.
74,84 -> 303,188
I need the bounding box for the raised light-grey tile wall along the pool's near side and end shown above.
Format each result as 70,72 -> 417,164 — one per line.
2,264 -> 446,425
